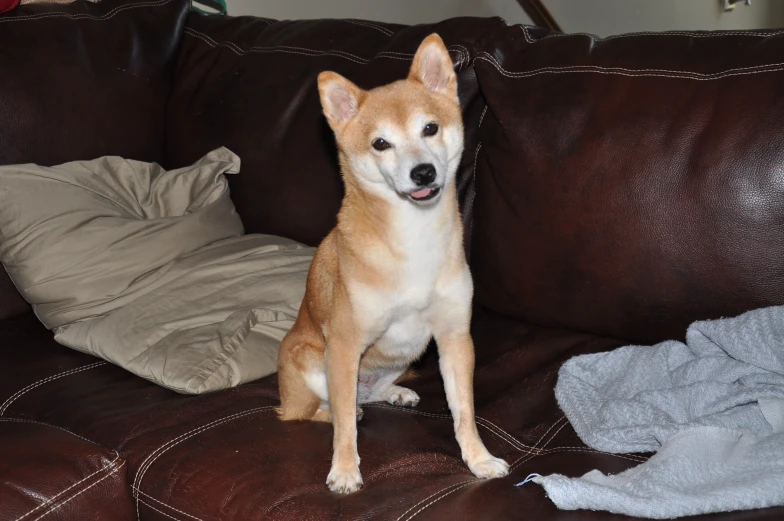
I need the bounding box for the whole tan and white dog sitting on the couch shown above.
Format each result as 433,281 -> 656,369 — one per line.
278,34 -> 509,493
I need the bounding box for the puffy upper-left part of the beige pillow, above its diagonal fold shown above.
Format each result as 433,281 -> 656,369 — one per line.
0,149 -> 243,329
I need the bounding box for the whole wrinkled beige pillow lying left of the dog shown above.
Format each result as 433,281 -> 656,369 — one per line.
0,148 -> 314,393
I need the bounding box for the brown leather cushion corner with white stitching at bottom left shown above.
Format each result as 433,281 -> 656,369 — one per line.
0,418 -> 136,521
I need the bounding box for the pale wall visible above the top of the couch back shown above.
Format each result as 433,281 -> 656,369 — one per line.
227,0 -> 784,36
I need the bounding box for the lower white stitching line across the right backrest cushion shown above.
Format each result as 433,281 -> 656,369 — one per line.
474,52 -> 784,81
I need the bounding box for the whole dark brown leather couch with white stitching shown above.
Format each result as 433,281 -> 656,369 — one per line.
0,0 -> 784,521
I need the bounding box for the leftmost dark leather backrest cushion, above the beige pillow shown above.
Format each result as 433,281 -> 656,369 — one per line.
0,0 -> 190,319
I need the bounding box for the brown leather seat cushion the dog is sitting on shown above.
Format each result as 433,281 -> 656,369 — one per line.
0,309 -> 784,521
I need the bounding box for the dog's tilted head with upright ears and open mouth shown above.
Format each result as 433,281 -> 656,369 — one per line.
318,34 -> 463,206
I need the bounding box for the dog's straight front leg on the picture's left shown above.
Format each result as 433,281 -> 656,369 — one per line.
327,336 -> 362,494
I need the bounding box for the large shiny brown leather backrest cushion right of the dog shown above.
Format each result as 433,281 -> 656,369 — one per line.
472,26 -> 784,342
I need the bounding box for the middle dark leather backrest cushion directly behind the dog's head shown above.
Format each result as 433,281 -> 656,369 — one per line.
167,13 -> 505,245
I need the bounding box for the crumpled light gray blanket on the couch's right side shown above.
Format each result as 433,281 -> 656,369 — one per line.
533,306 -> 784,519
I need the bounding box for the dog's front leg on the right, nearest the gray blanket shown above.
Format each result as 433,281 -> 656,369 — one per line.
436,331 -> 509,478
